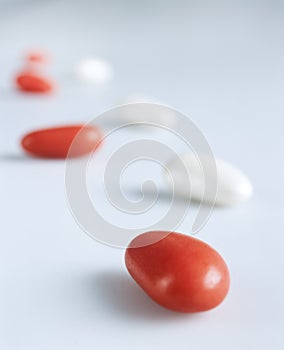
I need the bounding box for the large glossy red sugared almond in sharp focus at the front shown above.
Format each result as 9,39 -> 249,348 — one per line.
125,231 -> 230,313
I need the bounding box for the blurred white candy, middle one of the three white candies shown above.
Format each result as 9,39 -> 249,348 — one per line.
119,94 -> 177,128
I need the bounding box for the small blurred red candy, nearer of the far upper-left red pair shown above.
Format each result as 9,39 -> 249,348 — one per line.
16,72 -> 54,93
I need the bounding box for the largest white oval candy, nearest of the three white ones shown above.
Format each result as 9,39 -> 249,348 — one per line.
165,152 -> 253,206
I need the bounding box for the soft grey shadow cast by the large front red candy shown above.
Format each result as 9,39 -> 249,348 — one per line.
83,271 -> 198,322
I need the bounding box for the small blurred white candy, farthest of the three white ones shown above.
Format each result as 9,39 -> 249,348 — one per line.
75,58 -> 113,85
